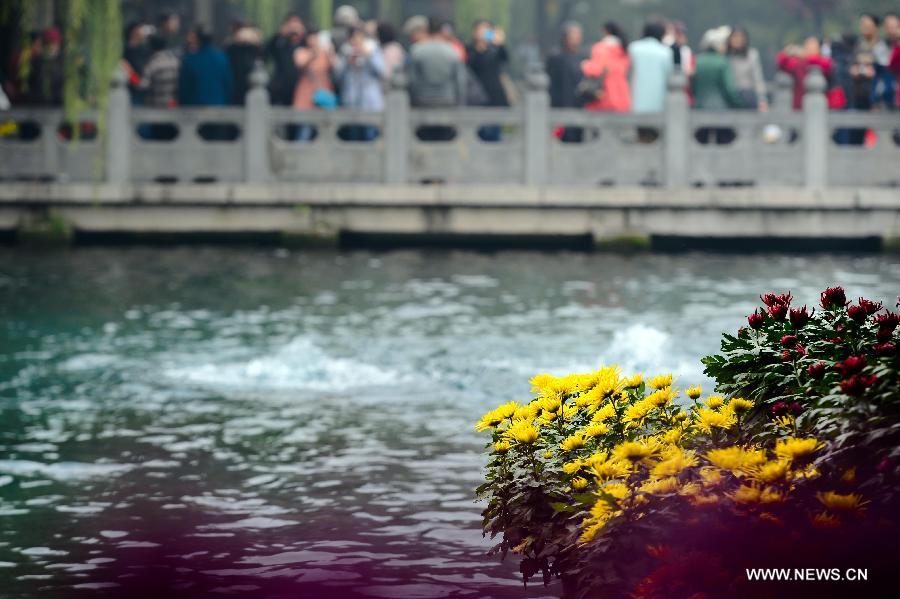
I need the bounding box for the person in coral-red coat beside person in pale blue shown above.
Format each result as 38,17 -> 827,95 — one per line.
581,22 -> 631,112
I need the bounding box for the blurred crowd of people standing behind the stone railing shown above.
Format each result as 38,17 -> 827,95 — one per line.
0,5 -> 900,143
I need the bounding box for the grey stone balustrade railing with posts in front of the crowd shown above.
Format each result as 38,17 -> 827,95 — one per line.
0,70 -> 900,189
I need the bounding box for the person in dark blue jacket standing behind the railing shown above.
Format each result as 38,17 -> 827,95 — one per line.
178,27 -> 234,106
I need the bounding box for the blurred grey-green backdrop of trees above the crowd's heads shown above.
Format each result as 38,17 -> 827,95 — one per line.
7,0 -> 897,78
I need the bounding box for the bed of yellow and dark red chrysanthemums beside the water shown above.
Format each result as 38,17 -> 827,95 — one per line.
476,288 -> 900,597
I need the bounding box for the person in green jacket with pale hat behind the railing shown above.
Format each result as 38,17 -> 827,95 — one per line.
691,27 -> 743,110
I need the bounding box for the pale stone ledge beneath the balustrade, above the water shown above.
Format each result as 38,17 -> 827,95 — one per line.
0,183 -> 900,247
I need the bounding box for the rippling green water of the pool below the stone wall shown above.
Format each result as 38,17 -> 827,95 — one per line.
0,247 -> 900,598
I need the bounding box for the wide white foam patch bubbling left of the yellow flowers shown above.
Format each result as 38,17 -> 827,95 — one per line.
164,337 -> 401,391
